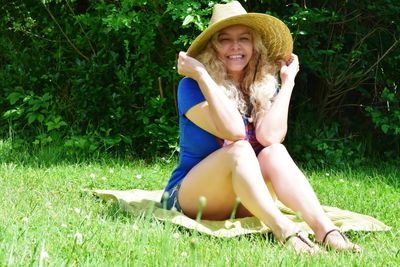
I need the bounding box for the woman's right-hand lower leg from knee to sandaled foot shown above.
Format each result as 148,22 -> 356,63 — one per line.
258,144 -> 360,252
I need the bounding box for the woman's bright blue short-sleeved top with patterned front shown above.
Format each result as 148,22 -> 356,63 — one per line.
165,77 -> 263,195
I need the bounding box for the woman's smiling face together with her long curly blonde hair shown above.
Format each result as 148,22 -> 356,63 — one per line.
195,25 -> 278,121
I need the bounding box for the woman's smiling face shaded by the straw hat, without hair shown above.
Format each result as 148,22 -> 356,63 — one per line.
217,25 -> 253,79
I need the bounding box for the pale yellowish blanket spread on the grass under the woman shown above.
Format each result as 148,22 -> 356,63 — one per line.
94,189 -> 390,237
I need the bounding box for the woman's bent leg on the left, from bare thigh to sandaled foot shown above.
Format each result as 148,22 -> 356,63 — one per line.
178,141 -> 314,252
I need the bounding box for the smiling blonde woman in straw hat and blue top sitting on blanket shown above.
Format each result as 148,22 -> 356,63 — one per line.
164,1 -> 361,253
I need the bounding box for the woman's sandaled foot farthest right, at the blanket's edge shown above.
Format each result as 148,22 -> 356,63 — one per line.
317,229 -> 361,253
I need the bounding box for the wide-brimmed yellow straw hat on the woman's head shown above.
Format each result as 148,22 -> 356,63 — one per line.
187,1 -> 293,61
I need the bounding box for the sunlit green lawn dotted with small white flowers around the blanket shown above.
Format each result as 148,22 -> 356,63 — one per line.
0,143 -> 400,266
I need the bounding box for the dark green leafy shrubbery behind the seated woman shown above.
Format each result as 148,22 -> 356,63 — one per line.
0,0 -> 400,165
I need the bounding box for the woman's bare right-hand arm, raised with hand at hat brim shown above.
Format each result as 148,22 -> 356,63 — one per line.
256,54 -> 299,146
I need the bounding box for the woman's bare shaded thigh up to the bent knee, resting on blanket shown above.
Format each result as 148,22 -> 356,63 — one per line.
178,141 -> 257,220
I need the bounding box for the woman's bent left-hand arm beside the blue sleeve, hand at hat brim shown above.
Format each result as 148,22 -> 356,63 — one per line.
178,52 -> 246,141
